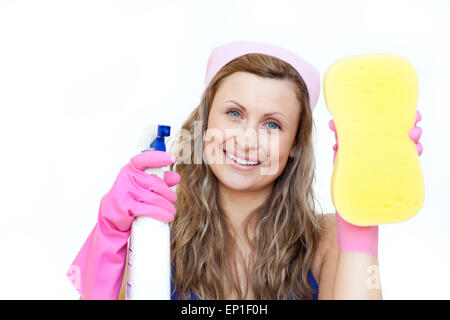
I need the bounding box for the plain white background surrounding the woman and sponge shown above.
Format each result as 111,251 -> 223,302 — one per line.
0,0 -> 450,299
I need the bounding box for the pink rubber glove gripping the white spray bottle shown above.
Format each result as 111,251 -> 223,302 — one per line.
67,150 -> 180,299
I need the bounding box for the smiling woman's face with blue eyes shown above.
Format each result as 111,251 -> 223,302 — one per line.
204,72 -> 300,191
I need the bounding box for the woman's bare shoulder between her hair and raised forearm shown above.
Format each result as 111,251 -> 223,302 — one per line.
311,213 -> 337,281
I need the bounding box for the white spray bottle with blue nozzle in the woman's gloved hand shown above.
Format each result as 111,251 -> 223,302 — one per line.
126,125 -> 173,300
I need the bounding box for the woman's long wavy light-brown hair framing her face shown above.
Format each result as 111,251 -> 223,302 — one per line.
170,54 -> 322,300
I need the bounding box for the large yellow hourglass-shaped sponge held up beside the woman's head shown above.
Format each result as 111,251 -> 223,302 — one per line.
323,54 -> 424,226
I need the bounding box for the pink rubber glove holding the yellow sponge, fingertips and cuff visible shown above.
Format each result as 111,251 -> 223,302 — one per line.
328,111 -> 423,256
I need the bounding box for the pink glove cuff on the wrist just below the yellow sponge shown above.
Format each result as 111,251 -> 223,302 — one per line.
336,211 -> 378,256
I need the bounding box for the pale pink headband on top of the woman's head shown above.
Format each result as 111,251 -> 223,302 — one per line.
204,41 -> 320,112
